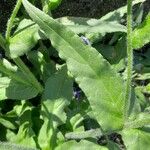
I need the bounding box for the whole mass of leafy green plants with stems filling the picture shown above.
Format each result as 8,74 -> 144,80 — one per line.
0,0 -> 150,150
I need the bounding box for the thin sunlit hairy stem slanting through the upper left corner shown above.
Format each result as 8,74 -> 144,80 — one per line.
5,0 -> 22,40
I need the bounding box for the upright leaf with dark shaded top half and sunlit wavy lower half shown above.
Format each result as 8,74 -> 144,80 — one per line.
38,66 -> 72,150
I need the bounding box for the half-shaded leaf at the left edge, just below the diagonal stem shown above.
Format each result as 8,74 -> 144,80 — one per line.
0,60 -> 38,100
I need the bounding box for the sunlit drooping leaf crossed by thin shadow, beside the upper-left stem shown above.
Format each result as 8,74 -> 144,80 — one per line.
8,19 -> 40,58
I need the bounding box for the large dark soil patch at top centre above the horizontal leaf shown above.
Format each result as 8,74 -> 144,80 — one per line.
51,0 -> 126,18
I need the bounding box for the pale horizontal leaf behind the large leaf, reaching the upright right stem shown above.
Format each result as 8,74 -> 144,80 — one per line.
57,17 -> 126,35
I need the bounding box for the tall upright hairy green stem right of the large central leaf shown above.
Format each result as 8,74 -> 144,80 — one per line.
125,0 -> 133,120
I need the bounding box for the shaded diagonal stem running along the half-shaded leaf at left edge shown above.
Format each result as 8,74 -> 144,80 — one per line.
14,58 -> 43,93
